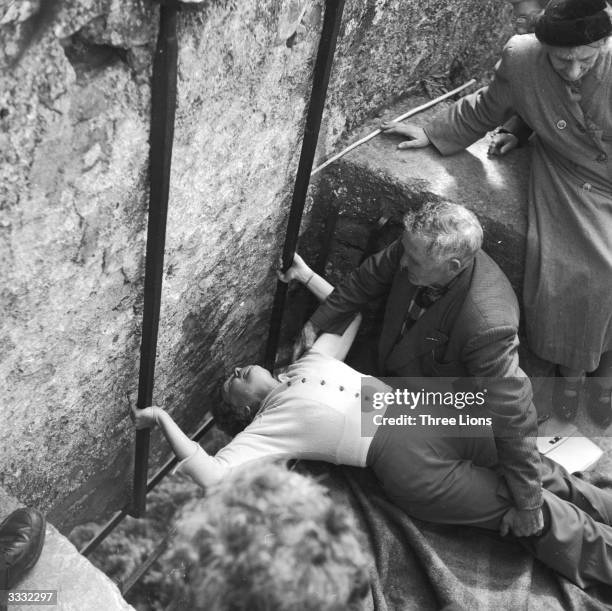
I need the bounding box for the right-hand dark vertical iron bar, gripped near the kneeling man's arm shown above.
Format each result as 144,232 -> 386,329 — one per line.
264,0 -> 344,371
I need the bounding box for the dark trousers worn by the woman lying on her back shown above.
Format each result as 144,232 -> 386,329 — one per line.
368,426 -> 612,587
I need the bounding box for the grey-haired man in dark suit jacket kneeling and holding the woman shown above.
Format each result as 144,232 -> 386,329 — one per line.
301,202 -> 544,536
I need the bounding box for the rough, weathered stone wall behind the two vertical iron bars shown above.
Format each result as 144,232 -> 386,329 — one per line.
0,0 -> 508,528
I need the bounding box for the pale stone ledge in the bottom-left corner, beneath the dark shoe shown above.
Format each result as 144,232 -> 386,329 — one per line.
0,488 -> 133,611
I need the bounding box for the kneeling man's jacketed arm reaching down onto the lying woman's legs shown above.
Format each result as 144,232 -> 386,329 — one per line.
462,326 -> 542,536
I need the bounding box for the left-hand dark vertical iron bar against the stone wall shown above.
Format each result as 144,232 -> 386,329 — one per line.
129,0 -> 178,518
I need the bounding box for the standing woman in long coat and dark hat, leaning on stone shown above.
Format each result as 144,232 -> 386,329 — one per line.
382,0 -> 612,426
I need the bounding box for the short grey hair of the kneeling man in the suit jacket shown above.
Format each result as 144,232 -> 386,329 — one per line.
404,202 -> 482,263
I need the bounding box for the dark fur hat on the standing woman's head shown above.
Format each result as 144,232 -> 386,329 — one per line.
535,0 -> 612,47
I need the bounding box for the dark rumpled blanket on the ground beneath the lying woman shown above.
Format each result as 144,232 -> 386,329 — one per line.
300,462 -> 612,611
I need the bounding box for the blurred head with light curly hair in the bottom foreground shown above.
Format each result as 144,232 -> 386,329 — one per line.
164,462 -> 369,611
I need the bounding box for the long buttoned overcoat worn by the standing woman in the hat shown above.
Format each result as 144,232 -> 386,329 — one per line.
425,35 -> 612,371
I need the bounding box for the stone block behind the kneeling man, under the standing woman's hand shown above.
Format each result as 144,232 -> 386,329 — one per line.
321,98 -> 529,294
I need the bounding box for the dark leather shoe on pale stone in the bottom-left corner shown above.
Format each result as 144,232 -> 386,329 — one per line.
0,507 -> 46,590
